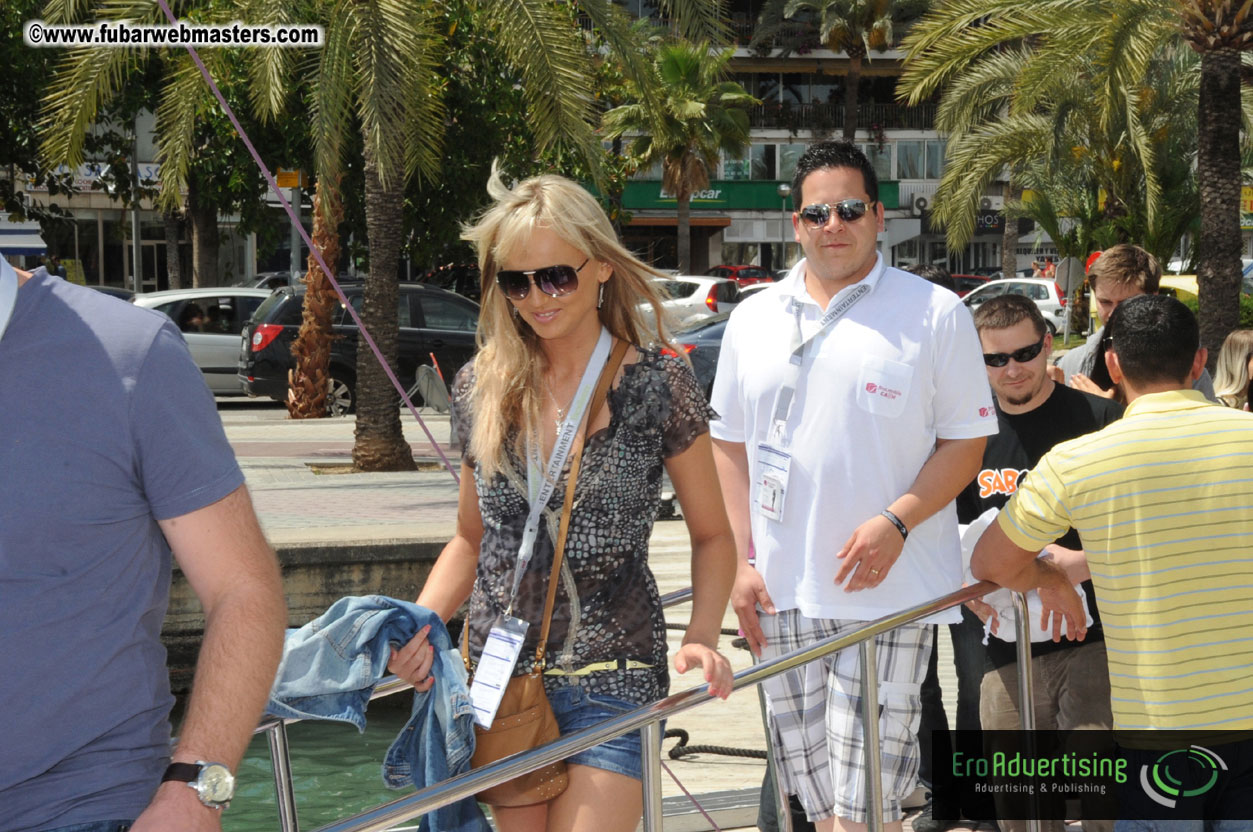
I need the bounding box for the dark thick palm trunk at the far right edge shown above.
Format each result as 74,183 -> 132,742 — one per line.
1197,49 -> 1240,372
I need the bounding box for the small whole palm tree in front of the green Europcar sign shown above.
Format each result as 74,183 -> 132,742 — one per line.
603,41 -> 758,272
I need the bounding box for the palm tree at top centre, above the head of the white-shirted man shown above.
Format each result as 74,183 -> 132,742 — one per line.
753,0 -> 931,142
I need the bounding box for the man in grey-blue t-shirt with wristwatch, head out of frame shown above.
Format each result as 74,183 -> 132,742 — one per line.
0,261 -> 286,832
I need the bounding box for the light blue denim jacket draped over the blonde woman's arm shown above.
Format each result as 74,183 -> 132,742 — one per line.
266,595 -> 489,832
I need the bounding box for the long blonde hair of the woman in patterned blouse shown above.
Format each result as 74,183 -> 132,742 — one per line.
461,167 -> 672,477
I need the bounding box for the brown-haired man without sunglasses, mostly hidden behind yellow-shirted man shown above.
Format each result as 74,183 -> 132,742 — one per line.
1049,243 -> 1218,401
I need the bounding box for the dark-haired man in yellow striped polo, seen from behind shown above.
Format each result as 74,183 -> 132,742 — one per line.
971,296 -> 1253,832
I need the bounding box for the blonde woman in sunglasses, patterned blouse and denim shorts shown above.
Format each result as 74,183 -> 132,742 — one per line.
391,170 -> 736,832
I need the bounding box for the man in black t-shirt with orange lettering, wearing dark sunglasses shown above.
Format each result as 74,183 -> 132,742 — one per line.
957,294 -> 1123,832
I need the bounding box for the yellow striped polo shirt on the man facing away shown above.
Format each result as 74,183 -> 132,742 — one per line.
999,390 -> 1253,729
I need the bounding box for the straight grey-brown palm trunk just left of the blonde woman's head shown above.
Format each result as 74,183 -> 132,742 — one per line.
352,137 -> 417,471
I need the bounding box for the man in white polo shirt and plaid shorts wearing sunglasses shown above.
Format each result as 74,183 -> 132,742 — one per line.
712,142 -> 996,831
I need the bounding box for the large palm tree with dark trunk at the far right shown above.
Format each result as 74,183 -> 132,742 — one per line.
900,0 -> 1253,363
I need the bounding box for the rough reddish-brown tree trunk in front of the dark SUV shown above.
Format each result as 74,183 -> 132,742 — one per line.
287,179 -> 343,419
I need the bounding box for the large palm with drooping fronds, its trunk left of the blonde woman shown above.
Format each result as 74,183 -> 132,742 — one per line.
246,0 -> 720,471
